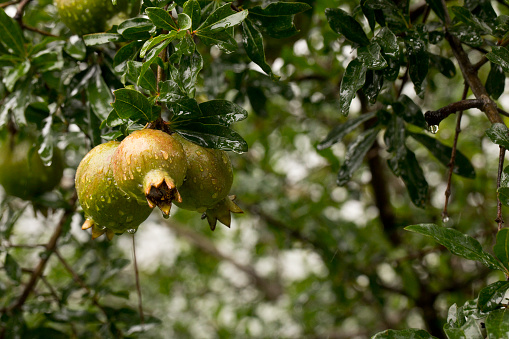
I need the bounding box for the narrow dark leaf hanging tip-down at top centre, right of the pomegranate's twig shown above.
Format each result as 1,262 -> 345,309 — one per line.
242,20 -> 279,80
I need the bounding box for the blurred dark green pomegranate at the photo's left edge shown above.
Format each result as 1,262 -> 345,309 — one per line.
0,131 -> 64,200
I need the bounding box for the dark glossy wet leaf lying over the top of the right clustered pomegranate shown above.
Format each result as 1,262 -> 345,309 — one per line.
175,122 -> 248,153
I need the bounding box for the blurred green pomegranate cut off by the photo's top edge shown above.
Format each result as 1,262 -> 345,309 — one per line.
55,0 -> 141,35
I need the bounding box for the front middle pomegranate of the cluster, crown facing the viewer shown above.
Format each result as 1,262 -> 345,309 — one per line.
112,129 -> 187,217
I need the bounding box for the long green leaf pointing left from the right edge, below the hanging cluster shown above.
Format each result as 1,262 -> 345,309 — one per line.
405,224 -> 505,271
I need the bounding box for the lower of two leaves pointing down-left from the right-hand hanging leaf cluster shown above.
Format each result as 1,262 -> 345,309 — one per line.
336,128 -> 380,186
